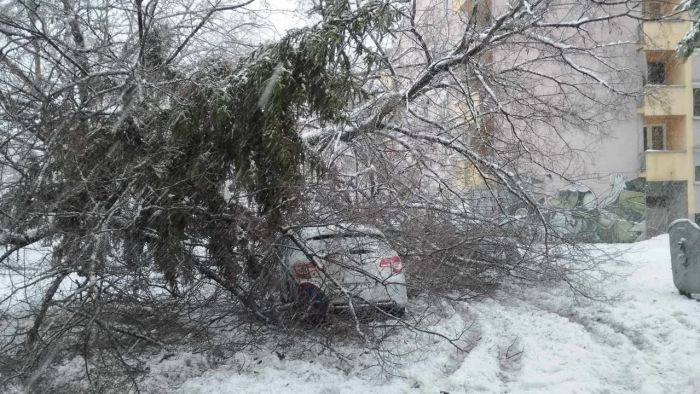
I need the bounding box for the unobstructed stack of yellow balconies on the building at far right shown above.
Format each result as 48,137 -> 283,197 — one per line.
639,1 -> 700,235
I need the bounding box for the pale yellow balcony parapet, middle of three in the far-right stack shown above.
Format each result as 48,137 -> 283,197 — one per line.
642,85 -> 692,116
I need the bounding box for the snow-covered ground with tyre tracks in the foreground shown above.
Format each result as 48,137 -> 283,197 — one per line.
170,236 -> 700,394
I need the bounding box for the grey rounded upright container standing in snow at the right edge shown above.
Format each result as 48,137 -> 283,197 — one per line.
668,219 -> 700,296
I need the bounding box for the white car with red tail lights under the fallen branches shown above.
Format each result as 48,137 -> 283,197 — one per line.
278,225 -> 407,316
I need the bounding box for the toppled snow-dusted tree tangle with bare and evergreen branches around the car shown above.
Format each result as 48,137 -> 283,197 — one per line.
0,0 -> 637,389
